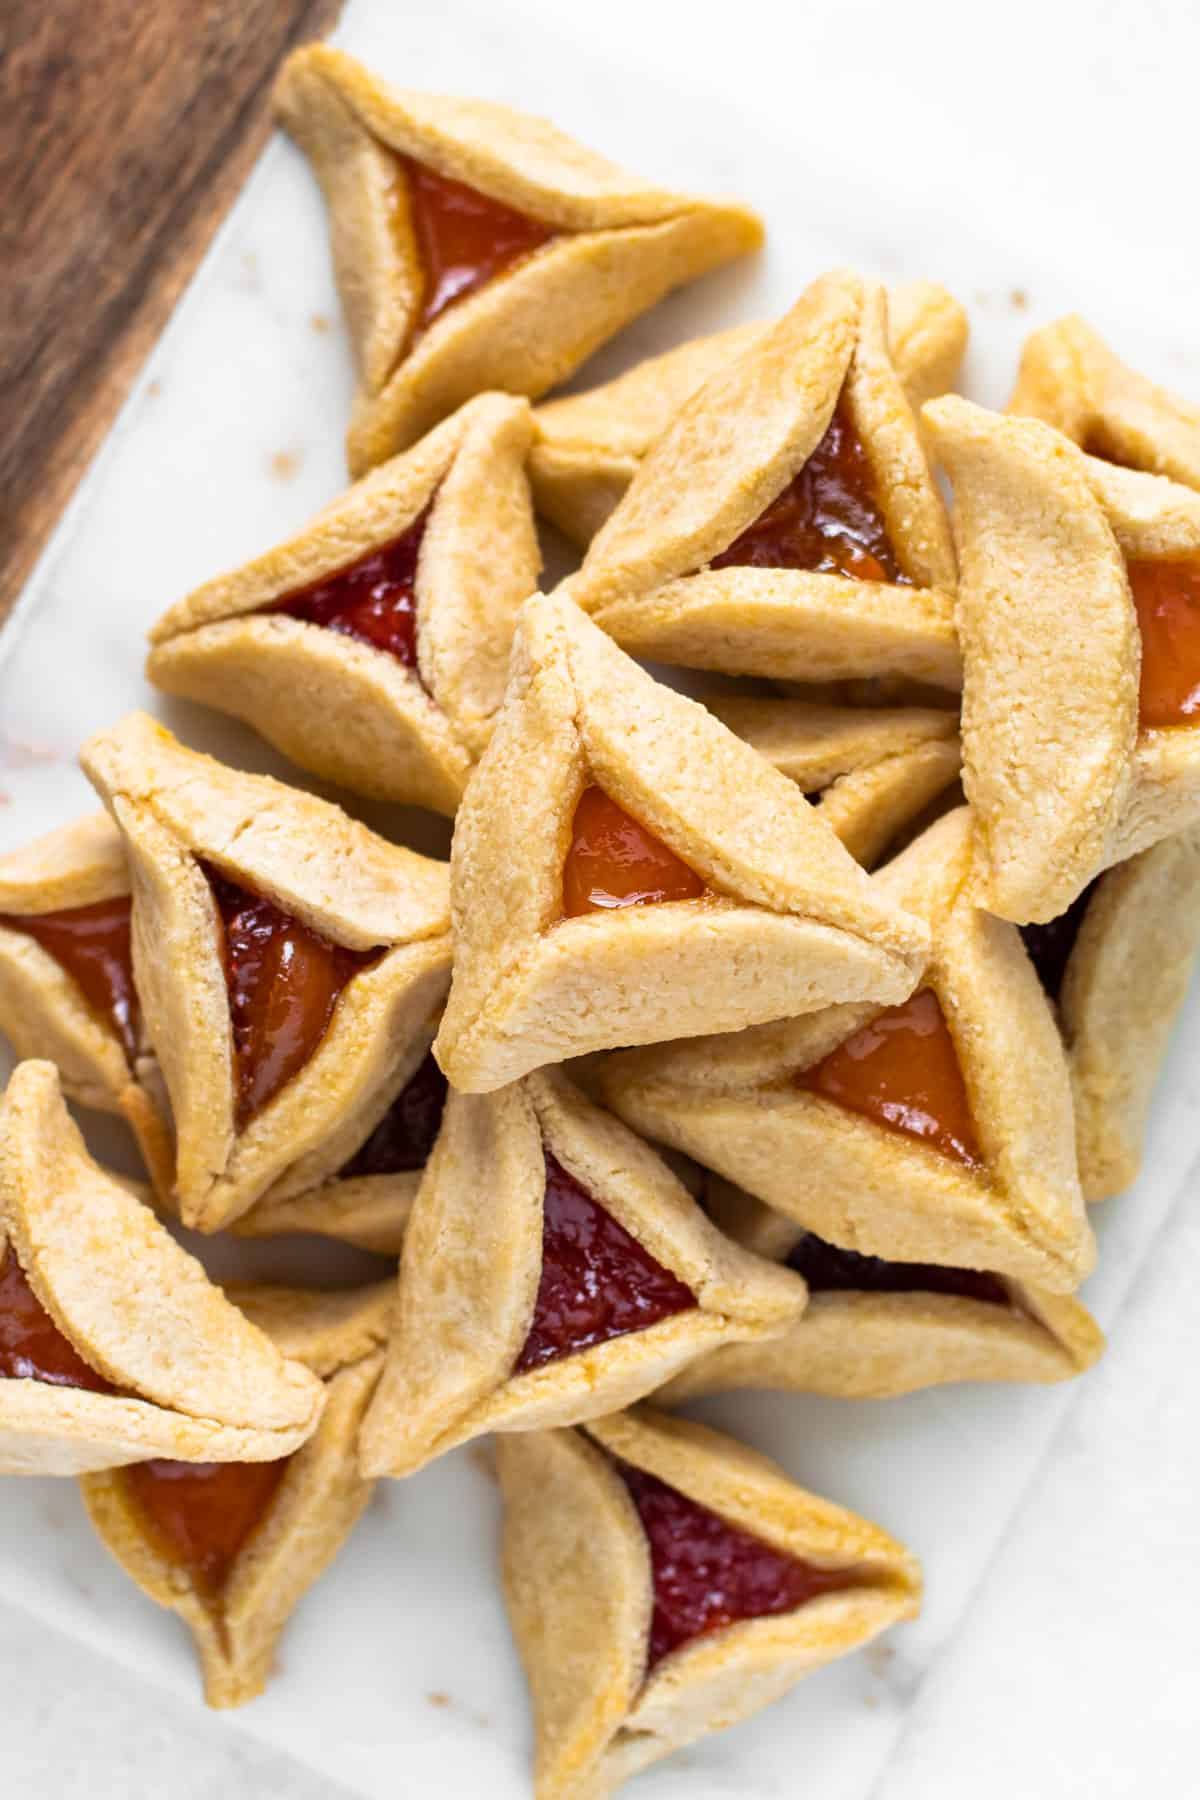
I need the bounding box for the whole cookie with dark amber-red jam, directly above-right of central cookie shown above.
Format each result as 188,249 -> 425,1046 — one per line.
565,270 -> 961,689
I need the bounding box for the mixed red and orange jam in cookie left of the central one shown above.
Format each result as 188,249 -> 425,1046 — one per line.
203,864 -> 378,1130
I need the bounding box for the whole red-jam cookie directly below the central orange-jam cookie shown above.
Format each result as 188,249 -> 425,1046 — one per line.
360,1069 -> 804,1476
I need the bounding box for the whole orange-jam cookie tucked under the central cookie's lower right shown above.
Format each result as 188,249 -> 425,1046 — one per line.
597,808 -> 1096,1292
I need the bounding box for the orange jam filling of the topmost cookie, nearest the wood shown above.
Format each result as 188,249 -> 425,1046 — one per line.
401,158 -> 554,331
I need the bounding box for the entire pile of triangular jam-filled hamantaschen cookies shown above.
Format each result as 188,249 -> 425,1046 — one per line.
0,49 -> 1200,1800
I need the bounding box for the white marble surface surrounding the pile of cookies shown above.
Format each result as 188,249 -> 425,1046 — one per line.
0,0 -> 1200,1800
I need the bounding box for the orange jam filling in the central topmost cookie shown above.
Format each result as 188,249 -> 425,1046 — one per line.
563,787 -> 709,918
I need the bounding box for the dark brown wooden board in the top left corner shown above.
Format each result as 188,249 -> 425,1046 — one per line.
0,0 -> 340,619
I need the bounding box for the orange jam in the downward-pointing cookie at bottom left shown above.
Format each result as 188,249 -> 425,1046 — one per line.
122,1456 -> 290,1589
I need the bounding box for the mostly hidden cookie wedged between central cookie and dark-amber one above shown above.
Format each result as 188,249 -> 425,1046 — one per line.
703,695 -> 963,869
